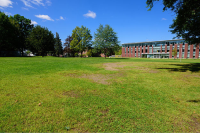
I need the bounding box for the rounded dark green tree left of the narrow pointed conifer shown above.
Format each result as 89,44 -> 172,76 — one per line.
28,25 -> 55,56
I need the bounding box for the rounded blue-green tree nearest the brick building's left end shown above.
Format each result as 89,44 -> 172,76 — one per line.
93,24 -> 119,58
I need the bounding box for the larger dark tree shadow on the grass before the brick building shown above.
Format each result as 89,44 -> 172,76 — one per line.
157,63 -> 200,72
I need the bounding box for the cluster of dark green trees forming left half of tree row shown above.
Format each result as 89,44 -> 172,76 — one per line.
0,12 -> 62,56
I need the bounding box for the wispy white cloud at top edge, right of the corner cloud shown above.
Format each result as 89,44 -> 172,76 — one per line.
21,0 -> 51,8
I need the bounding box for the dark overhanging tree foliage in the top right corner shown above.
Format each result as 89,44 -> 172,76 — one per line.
147,0 -> 200,44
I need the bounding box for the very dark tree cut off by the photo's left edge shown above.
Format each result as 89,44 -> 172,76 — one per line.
0,12 -> 18,51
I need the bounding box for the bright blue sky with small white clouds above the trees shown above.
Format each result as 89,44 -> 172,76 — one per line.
0,0 -> 178,44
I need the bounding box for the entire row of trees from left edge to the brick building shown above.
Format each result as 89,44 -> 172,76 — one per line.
0,12 -> 120,57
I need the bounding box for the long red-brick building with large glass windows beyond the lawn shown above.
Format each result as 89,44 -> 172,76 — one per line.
122,39 -> 200,58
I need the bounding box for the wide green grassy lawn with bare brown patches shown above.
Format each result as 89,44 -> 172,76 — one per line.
0,57 -> 200,132
